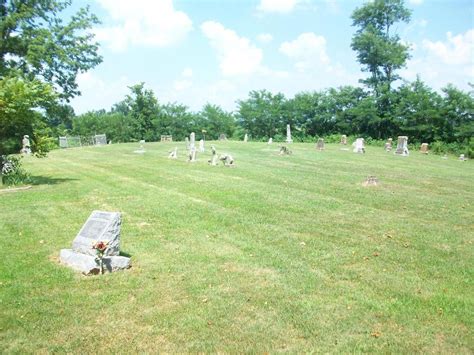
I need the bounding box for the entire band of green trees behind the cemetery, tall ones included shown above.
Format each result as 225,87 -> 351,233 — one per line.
0,0 -> 474,156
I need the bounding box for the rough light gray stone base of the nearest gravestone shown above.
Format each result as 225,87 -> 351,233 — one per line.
59,249 -> 130,275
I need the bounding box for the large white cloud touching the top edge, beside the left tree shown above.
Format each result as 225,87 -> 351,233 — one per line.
95,0 -> 192,51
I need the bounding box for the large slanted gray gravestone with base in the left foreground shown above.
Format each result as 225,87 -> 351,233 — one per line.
60,211 -> 130,274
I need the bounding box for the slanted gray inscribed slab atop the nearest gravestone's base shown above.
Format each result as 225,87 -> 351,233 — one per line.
72,211 -> 122,256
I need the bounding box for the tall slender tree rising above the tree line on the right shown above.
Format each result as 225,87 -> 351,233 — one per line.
351,0 -> 411,96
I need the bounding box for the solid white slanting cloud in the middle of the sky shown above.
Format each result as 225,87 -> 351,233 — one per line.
201,21 -> 263,76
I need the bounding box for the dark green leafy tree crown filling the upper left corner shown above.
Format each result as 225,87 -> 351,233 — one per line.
0,0 -> 102,100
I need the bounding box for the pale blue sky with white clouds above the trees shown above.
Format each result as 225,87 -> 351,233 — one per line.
68,0 -> 474,114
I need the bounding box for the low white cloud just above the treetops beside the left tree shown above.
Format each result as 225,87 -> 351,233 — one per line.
71,72 -> 132,114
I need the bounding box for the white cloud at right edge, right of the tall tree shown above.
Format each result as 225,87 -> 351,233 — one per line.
423,29 -> 474,65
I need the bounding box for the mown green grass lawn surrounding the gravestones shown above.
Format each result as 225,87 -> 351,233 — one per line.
0,142 -> 474,353
